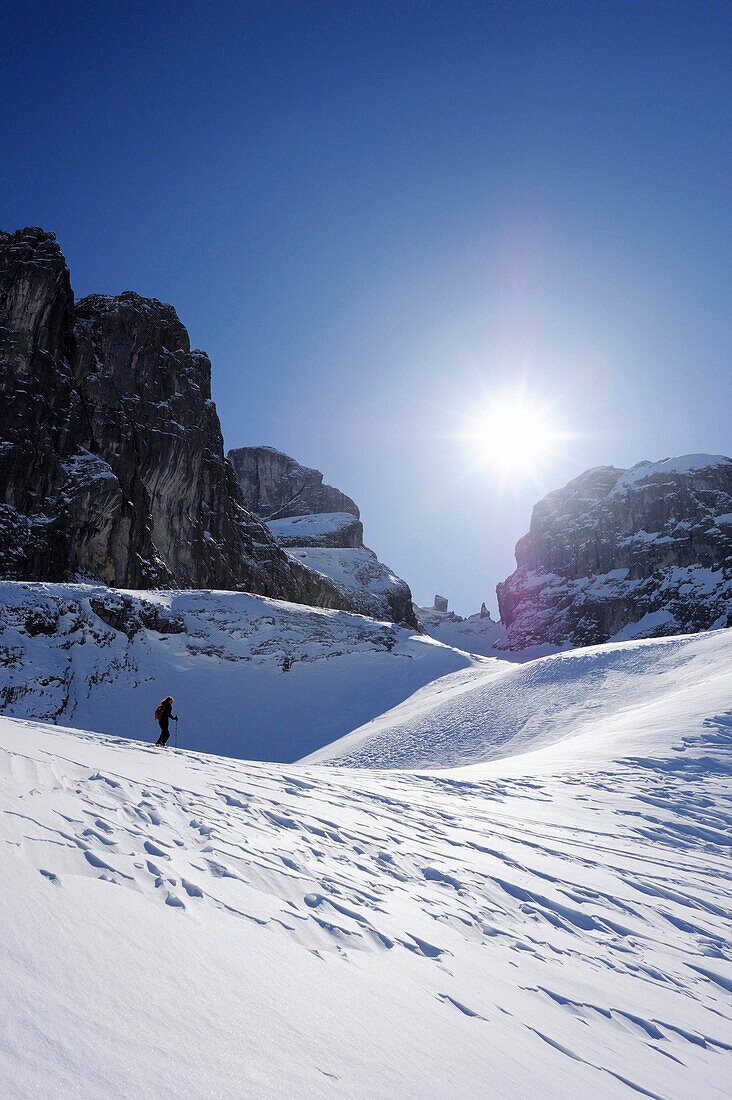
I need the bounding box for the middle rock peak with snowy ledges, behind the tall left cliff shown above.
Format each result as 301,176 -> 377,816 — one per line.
229,447 -> 419,629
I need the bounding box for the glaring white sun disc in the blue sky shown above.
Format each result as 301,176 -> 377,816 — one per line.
460,393 -> 570,481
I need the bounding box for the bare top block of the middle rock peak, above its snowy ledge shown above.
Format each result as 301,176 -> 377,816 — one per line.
228,447 -> 359,519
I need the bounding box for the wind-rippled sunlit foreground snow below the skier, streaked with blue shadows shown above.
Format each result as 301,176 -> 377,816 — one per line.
0,712 -> 732,1100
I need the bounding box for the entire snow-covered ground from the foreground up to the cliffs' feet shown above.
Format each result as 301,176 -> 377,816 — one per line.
0,585 -> 732,1100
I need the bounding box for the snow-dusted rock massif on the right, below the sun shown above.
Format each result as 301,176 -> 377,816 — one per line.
496,454 -> 732,649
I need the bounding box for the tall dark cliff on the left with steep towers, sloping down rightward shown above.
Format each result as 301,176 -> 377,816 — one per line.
0,228 -> 348,607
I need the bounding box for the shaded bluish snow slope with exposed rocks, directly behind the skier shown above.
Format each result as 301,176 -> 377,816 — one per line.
0,581 -> 471,761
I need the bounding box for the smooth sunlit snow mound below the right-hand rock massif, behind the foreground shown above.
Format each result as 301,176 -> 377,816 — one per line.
305,630 -> 732,773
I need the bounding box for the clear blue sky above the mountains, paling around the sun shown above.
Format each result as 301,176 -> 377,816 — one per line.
0,0 -> 732,613
